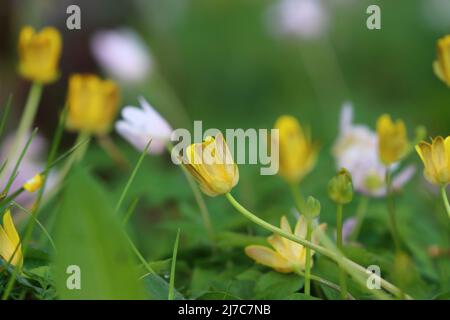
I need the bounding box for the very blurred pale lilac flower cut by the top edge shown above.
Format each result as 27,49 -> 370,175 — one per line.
269,0 -> 329,39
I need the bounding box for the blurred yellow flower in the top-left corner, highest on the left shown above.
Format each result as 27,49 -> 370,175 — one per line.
18,26 -> 62,83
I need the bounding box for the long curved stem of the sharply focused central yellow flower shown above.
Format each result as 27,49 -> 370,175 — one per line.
225,193 -> 411,299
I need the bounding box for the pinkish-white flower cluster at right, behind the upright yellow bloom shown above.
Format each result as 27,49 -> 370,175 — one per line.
333,103 -> 416,197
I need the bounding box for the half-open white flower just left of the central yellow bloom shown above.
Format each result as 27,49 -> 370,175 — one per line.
116,97 -> 172,154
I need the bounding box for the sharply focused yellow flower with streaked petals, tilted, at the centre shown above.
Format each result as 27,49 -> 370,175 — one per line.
183,133 -> 239,197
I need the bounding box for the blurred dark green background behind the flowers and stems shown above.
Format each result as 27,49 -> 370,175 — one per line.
0,0 -> 450,300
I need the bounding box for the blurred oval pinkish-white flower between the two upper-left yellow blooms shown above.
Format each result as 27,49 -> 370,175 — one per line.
91,29 -> 153,83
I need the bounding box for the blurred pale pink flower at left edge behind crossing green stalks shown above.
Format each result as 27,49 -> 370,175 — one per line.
0,134 -> 56,206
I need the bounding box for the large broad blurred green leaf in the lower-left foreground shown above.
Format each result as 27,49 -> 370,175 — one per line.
55,168 -> 145,299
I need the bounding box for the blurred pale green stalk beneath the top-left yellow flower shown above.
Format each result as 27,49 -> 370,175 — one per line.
0,82 -> 43,180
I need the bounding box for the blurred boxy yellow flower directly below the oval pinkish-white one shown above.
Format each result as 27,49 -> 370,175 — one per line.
67,74 -> 119,134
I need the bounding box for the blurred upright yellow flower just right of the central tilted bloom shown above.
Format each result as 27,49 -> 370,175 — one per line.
275,116 -> 318,183
